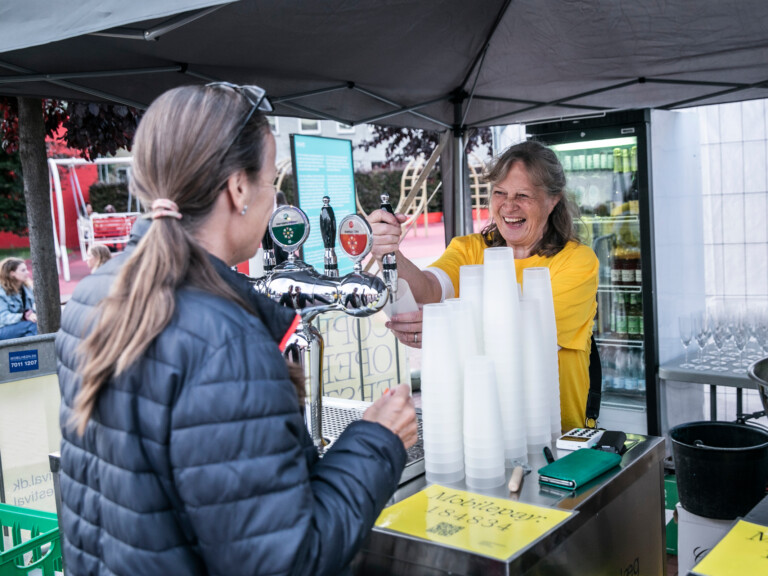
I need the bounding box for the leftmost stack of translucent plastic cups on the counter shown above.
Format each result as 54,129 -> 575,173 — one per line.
421,304 -> 464,483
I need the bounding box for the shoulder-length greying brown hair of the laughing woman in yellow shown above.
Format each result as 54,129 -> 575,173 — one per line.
481,140 -> 579,257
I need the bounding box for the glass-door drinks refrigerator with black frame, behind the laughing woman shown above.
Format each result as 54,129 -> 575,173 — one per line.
526,110 -> 703,435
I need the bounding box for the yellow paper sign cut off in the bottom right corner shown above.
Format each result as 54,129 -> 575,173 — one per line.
693,520 -> 768,576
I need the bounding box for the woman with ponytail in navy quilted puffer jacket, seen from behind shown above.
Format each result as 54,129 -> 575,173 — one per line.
56,84 -> 417,576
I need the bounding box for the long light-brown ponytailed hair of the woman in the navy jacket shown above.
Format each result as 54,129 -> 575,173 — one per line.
73,86 -> 303,434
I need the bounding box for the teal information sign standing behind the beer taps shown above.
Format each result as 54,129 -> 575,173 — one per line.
291,134 -> 357,276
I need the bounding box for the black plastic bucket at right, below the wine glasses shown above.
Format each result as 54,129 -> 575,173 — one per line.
669,422 -> 768,520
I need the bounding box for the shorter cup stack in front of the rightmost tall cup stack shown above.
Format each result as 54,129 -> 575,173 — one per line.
520,298 -> 553,454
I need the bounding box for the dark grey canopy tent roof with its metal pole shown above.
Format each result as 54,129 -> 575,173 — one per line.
0,0 -> 768,234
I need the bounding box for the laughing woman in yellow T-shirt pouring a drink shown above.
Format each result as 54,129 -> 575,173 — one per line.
369,141 -> 599,430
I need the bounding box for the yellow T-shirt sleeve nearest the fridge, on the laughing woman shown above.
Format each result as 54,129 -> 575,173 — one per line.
549,244 -> 600,352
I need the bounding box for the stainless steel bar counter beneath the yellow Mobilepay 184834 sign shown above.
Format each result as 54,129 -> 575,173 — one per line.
352,434 -> 666,576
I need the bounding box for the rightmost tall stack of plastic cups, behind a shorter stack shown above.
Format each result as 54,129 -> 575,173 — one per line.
523,268 -> 561,438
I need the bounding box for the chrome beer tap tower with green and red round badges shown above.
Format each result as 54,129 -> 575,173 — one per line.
254,196 -> 390,451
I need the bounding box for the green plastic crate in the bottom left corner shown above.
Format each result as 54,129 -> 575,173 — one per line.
0,504 -> 64,576
